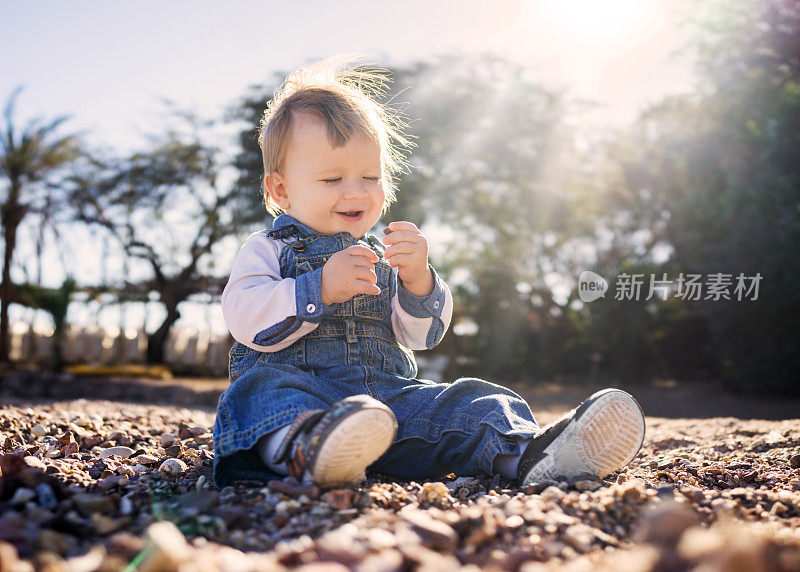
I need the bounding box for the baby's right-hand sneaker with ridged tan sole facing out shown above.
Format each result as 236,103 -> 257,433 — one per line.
517,389 -> 645,486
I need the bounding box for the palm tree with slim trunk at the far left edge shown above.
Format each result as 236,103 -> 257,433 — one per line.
0,87 -> 79,363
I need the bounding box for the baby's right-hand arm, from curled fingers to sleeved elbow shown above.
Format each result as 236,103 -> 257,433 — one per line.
383,221 -> 453,350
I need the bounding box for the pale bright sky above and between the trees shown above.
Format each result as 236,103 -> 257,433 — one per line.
0,0 -> 692,338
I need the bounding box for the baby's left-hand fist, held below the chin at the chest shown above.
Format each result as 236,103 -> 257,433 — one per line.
322,244 -> 381,305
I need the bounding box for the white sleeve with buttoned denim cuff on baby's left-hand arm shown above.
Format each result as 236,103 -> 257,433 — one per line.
222,231 -> 333,352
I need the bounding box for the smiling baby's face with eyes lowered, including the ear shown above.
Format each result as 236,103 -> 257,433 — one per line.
265,113 -> 385,238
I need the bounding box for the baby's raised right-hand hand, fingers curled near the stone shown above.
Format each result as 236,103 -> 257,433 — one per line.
382,221 -> 433,296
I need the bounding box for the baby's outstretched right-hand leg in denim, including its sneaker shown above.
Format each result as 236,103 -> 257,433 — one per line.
372,378 -> 644,484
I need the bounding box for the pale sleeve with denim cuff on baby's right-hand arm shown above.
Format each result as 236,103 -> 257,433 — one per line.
391,265 -> 453,350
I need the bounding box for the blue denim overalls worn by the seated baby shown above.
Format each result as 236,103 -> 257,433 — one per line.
214,219 -> 538,486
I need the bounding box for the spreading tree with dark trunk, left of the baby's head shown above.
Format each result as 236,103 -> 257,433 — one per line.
71,109 -> 252,363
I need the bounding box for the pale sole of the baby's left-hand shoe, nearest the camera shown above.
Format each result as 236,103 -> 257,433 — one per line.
312,408 -> 397,486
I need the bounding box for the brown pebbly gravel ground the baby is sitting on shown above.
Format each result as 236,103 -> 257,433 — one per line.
0,374 -> 800,572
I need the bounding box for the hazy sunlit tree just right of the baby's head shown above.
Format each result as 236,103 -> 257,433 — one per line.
389,55 -> 592,379
